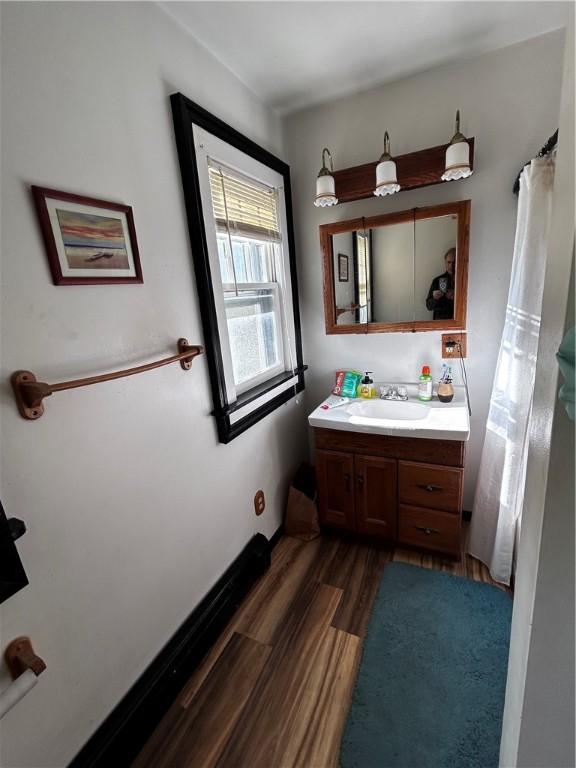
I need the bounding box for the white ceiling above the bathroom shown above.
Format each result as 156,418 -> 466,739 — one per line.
159,0 -> 571,114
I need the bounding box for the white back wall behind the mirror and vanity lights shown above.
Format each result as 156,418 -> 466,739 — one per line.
286,32 -> 564,508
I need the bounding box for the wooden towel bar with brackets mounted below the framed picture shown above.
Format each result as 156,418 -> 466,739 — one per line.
10,339 -> 203,420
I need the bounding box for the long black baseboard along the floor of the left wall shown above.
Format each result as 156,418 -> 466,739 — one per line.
69,527 -> 282,768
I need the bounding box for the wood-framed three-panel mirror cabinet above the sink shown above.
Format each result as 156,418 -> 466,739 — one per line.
320,200 -> 470,334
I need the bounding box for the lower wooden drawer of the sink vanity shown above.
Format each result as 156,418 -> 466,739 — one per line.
398,505 -> 460,557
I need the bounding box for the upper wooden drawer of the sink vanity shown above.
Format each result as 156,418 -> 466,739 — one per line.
398,461 -> 464,512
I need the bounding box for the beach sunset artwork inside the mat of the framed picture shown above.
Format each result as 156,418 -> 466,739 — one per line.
56,208 -> 130,270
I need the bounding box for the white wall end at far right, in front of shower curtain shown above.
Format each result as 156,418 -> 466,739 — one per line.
500,6 -> 575,768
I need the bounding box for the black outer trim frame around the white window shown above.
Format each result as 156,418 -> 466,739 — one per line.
170,93 -> 307,443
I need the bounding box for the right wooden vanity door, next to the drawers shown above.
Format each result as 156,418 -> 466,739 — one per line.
355,456 -> 398,539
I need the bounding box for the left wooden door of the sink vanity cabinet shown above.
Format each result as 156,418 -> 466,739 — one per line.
316,451 -> 355,531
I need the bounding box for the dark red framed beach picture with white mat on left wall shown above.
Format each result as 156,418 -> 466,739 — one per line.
32,187 -> 143,285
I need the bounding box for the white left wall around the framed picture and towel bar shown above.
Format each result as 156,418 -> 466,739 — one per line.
0,3 -> 306,768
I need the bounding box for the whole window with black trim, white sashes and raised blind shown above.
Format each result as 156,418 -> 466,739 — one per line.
172,94 -> 305,443
